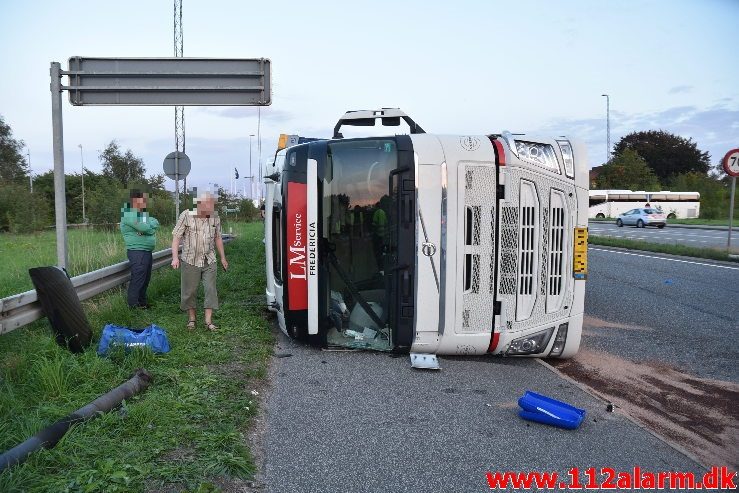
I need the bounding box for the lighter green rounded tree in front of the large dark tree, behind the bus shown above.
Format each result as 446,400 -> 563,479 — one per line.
595,149 -> 660,191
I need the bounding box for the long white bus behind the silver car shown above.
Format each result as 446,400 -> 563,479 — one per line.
588,190 -> 701,219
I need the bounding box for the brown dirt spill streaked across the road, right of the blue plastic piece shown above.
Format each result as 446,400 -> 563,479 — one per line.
550,349 -> 739,469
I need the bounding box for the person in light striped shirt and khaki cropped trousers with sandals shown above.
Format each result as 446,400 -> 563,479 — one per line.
172,192 -> 228,330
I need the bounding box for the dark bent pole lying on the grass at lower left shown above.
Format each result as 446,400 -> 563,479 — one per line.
0,368 -> 153,472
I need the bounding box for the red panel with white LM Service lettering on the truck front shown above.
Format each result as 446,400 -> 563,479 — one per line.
287,181 -> 308,310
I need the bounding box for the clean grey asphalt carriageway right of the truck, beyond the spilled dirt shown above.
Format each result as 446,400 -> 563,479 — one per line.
582,246 -> 739,383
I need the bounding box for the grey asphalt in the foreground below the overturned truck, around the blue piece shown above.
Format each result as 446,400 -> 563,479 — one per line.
262,328 -> 704,493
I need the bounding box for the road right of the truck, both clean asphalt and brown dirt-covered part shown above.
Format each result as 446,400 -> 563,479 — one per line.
551,247 -> 739,470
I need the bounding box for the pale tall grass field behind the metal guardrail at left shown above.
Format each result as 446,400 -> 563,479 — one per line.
0,226 -> 172,298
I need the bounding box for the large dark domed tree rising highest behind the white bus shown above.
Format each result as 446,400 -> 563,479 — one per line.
614,130 -> 711,181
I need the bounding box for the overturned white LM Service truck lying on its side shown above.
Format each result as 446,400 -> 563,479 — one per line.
265,109 -> 588,357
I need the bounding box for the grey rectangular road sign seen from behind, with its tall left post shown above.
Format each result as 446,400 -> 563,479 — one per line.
51,57 -> 272,268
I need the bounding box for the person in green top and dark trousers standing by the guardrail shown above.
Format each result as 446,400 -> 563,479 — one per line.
121,190 -> 159,309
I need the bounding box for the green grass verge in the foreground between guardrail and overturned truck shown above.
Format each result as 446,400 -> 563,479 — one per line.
0,223 -> 273,492
